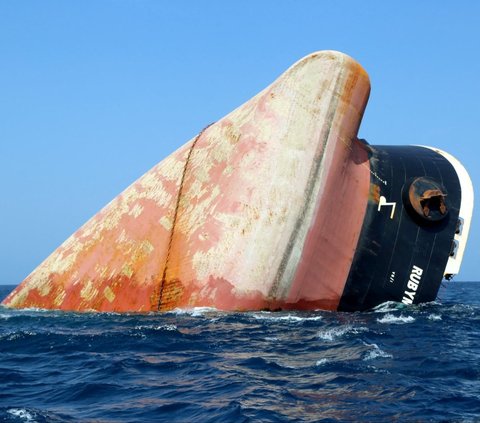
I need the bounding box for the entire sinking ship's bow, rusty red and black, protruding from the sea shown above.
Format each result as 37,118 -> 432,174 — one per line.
3,51 -> 473,312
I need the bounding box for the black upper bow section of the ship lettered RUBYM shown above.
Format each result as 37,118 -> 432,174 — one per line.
338,146 -> 461,311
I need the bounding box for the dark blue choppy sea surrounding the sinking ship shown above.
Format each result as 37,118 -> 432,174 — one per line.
0,282 -> 480,422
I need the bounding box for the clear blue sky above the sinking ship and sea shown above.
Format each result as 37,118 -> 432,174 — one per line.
0,0 -> 480,284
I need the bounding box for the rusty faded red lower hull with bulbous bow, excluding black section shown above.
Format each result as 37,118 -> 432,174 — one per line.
3,51 -> 371,312
